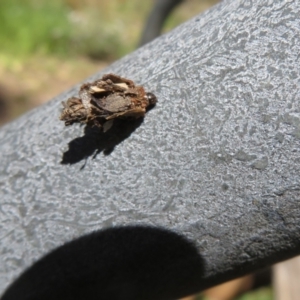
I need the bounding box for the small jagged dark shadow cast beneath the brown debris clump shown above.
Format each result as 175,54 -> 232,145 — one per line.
61,118 -> 144,168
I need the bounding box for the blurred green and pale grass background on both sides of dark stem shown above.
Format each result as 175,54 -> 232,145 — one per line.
0,0 -> 217,63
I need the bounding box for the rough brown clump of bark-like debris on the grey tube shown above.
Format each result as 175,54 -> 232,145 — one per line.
60,74 -> 157,131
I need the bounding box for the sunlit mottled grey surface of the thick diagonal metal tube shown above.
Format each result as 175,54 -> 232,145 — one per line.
0,0 -> 300,296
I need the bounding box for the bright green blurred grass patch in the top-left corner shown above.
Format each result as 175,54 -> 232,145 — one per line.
0,0 -> 72,57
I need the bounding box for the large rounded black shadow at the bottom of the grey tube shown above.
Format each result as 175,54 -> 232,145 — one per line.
1,225 -> 204,300
